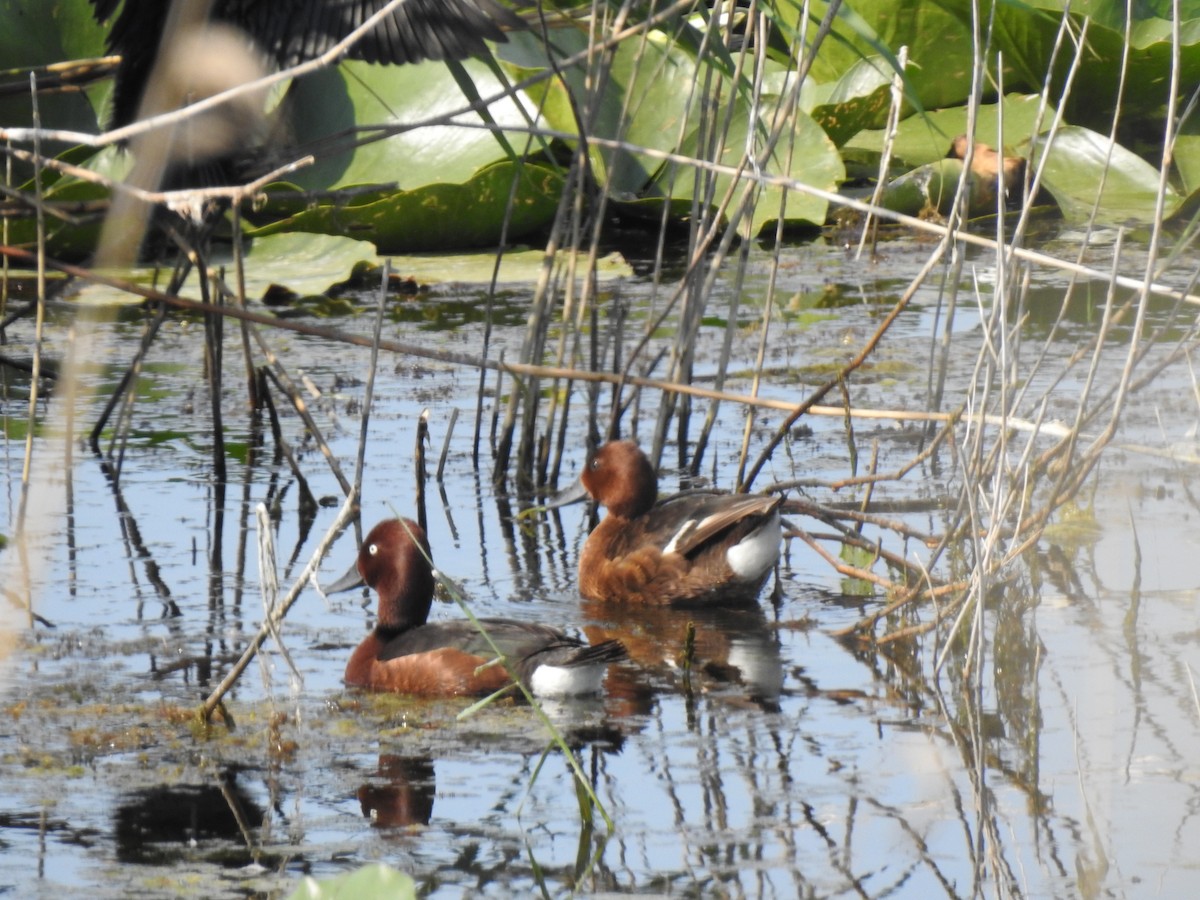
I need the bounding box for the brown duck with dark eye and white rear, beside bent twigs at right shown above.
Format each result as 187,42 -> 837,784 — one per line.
550,440 -> 784,606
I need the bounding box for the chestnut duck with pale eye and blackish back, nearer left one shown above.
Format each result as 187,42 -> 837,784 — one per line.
325,518 -> 626,697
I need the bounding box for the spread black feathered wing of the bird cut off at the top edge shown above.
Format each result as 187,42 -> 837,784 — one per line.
231,0 -> 526,66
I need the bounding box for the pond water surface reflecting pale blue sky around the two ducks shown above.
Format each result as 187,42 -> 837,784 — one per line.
0,226 -> 1200,898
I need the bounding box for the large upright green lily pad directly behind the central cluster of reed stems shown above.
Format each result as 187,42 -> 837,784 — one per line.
500,25 -> 845,236
